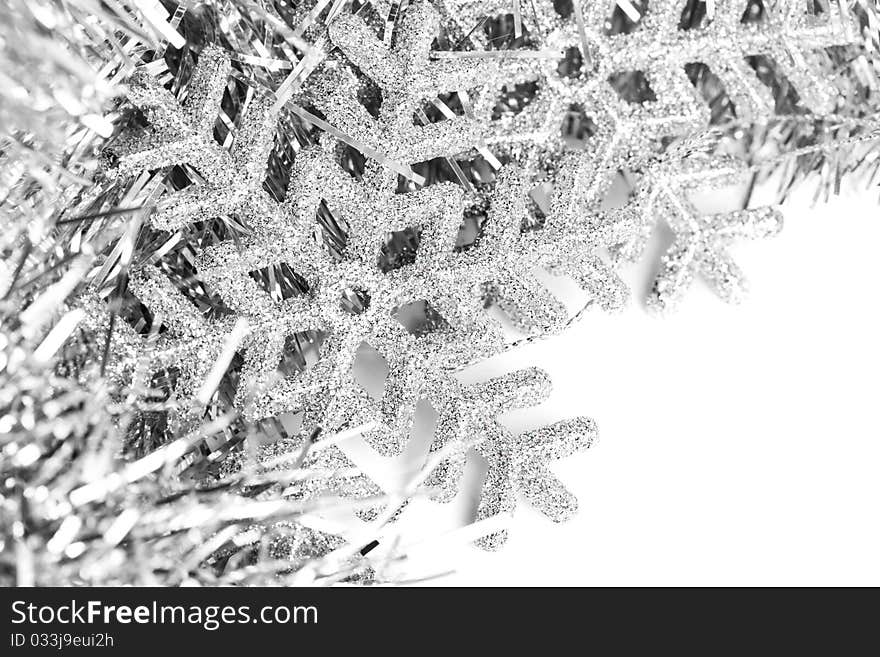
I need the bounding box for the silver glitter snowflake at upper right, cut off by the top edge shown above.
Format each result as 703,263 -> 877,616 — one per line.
436,0 -> 857,309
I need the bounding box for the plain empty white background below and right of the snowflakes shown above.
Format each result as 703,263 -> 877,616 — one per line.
332,184 -> 880,586
